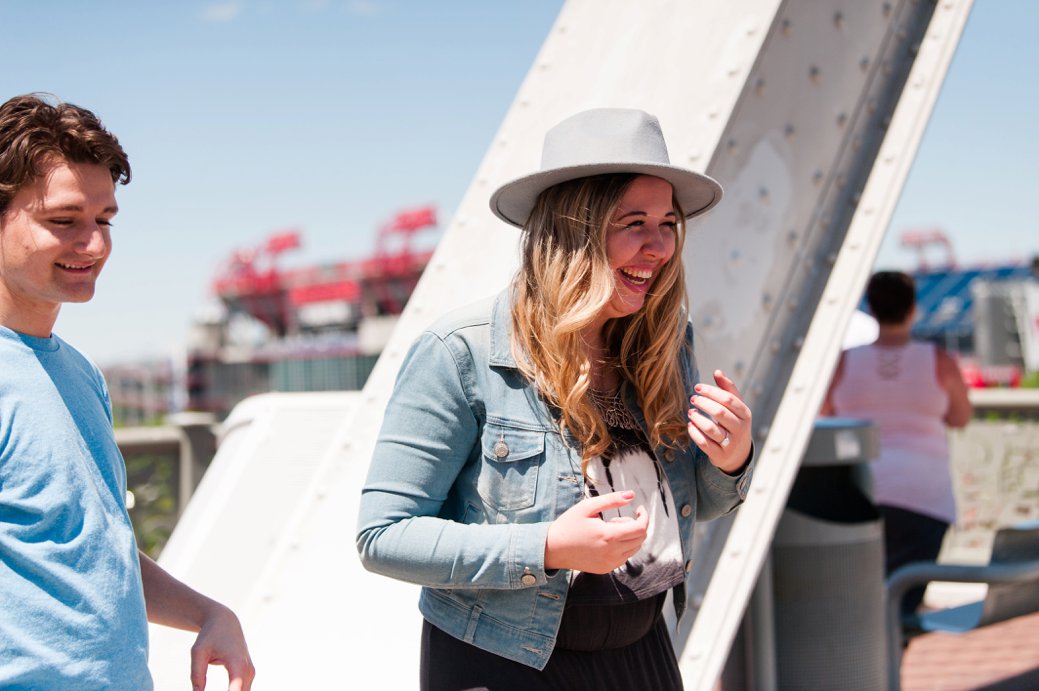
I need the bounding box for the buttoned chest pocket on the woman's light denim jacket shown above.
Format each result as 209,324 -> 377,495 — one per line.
477,418 -> 545,511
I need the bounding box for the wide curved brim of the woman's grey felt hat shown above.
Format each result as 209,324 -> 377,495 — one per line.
490,163 -> 722,228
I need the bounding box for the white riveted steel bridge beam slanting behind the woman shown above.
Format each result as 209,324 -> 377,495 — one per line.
144,0 -> 970,691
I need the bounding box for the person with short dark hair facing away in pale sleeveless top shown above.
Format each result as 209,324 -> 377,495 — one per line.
822,271 -> 971,613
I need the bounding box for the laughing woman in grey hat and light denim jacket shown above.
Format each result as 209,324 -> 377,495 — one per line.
357,108 -> 752,691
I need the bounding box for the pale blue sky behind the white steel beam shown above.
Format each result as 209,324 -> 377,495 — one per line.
0,0 -> 1039,364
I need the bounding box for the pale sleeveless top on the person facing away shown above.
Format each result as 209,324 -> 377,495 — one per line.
831,343 -> 956,524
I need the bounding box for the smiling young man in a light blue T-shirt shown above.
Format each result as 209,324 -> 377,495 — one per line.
0,96 -> 255,691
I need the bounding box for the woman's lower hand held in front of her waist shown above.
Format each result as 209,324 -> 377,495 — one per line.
544,491 -> 649,574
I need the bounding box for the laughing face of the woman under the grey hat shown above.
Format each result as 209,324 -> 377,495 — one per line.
600,176 -> 678,323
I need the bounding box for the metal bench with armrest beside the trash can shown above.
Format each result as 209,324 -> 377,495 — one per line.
886,522 -> 1039,691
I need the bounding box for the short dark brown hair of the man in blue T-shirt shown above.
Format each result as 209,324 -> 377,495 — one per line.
0,94 -> 130,214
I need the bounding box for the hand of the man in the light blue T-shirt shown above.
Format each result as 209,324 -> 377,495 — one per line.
191,602 -> 256,691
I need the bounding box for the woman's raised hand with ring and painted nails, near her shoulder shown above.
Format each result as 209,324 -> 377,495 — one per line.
689,370 -> 751,474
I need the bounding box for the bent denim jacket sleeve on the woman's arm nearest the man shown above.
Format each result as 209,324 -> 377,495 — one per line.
357,331 -> 549,589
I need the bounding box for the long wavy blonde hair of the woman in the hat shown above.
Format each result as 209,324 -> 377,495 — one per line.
511,174 -> 689,470
